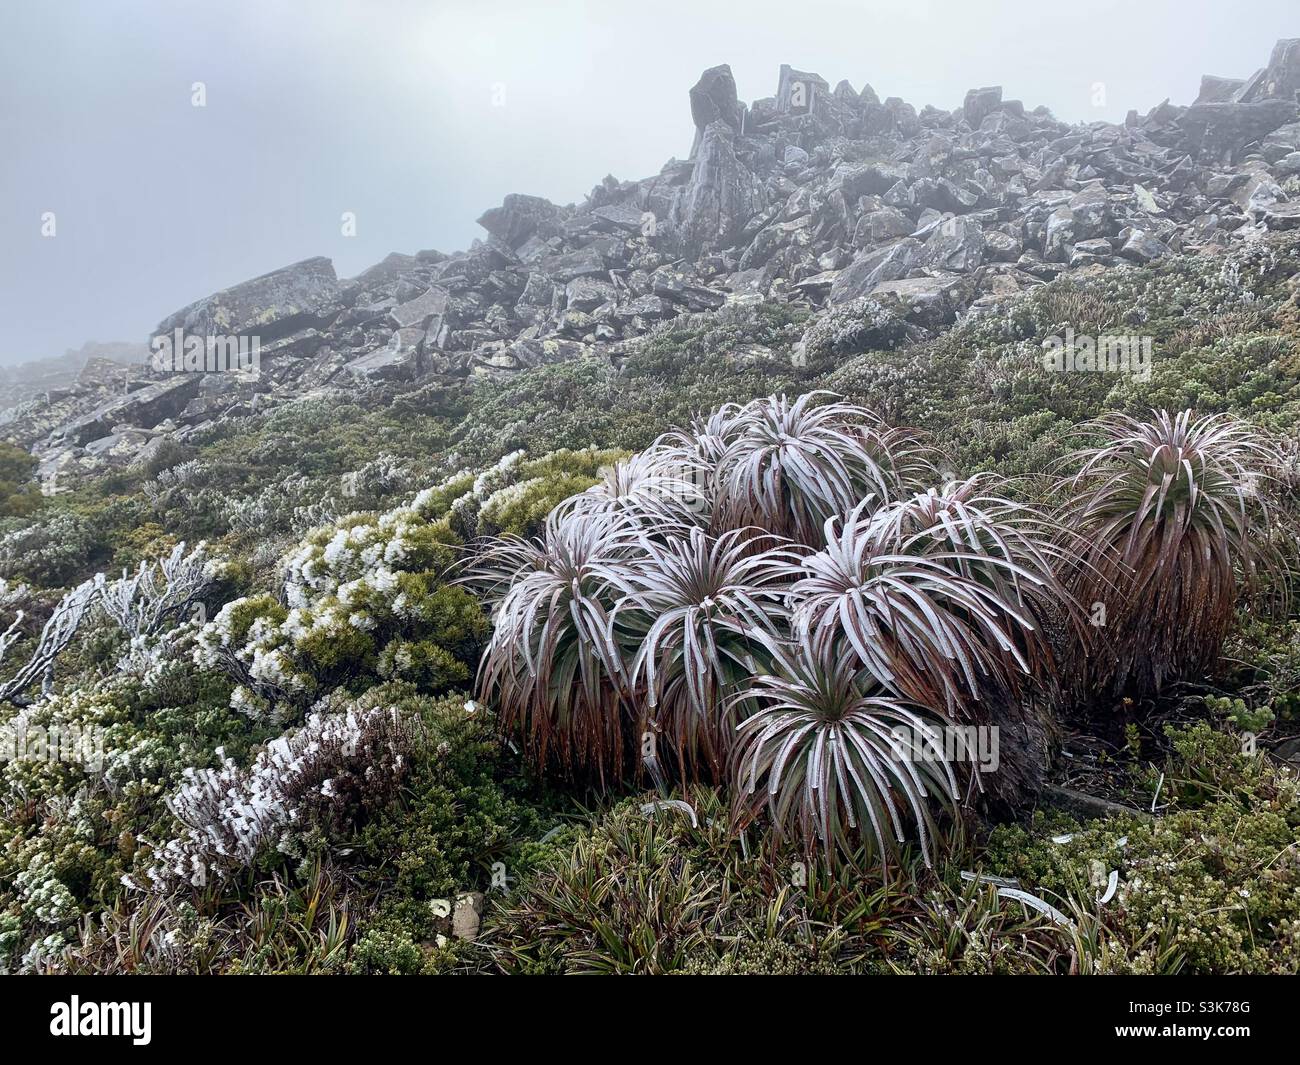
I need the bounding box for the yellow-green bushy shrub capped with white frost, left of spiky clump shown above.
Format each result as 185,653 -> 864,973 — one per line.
195,449 -> 620,720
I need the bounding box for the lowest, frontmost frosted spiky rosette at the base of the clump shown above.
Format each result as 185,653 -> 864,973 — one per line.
735,632 -> 958,865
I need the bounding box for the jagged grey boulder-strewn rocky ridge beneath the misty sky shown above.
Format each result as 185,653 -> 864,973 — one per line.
4,39 -> 1300,490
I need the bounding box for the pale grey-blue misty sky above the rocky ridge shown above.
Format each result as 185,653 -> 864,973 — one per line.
0,0 -> 1300,362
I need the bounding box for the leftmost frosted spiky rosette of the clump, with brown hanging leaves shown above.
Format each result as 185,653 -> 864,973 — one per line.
475,510 -> 638,784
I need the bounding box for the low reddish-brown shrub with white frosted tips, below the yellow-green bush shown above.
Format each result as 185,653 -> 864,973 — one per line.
131,706 -> 412,892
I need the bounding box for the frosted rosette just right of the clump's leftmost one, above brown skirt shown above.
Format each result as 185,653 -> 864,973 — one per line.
615,529 -> 797,780
